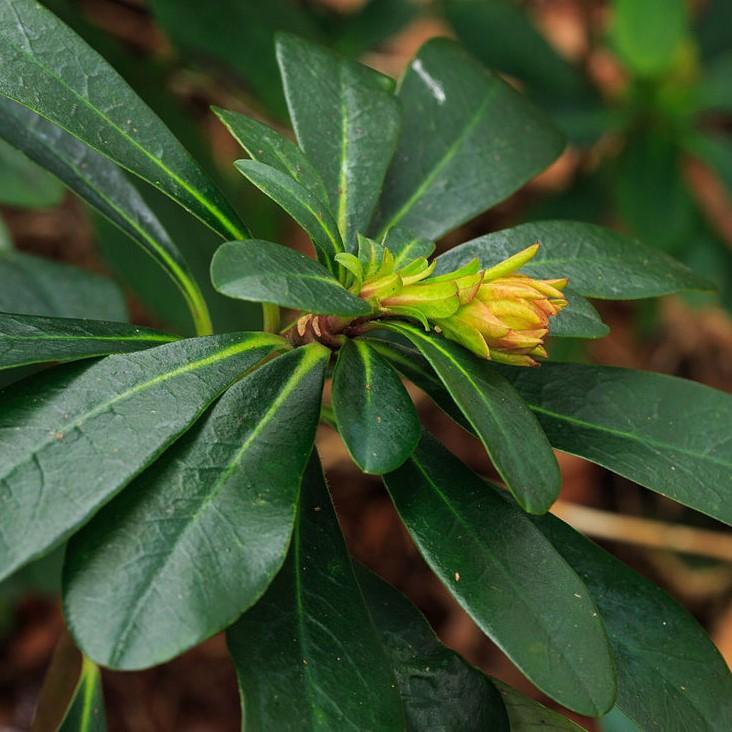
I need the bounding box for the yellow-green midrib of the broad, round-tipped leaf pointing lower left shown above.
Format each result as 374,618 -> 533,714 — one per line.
110,352 -> 323,663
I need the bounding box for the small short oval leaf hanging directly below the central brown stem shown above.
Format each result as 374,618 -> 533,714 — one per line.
332,340 -> 421,475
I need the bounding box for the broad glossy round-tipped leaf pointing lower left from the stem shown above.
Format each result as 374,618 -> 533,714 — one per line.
64,344 -> 330,669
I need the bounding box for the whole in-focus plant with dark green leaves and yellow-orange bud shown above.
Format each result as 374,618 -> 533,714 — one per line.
0,0 -> 732,730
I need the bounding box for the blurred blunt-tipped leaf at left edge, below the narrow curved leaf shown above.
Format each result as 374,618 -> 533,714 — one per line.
0,251 -> 127,321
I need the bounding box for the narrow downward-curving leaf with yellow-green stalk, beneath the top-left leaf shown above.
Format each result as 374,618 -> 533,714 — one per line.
0,98 -> 211,333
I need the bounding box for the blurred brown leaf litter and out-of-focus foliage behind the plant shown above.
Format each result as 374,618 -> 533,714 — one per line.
0,0 -> 732,732
